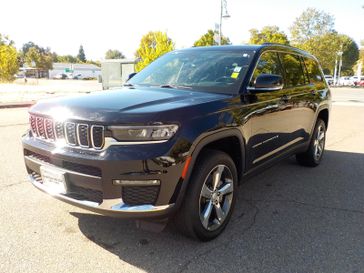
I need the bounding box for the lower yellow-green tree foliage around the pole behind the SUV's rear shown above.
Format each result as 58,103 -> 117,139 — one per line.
297,33 -> 359,75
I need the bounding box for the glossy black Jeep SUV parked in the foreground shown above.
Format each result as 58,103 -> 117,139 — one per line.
23,44 -> 331,240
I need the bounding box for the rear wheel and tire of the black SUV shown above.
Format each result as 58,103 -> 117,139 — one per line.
296,118 -> 326,167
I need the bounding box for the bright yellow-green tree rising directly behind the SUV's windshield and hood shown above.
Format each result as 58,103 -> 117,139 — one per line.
135,31 -> 174,71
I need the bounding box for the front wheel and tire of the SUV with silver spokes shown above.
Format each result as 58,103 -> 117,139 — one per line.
175,150 -> 238,241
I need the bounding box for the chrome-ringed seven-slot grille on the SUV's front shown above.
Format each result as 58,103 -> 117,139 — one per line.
29,115 -> 104,149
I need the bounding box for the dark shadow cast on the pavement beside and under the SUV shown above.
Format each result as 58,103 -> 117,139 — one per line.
71,151 -> 364,273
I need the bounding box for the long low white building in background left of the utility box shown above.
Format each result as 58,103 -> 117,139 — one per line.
48,63 -> 101,79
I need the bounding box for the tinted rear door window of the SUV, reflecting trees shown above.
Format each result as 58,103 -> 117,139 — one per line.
280,53 -> 306,87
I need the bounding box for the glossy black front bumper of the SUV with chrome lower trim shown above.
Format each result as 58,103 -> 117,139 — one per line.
23,132 -> 184,219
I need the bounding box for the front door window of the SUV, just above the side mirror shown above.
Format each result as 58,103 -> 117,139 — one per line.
249,51 -> 284,86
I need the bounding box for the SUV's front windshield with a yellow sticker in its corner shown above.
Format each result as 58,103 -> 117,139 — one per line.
128,50 -> 254,94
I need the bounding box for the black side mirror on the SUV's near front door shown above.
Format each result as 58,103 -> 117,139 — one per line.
248,74 -> 283,93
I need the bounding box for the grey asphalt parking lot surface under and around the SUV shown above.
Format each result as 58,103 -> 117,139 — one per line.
0,89 -> 364,273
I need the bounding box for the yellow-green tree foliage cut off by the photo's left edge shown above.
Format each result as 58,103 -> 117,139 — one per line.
0,41 -> 19,82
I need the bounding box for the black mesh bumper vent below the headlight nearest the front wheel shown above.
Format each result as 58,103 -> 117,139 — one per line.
121,186 -> 159,206
